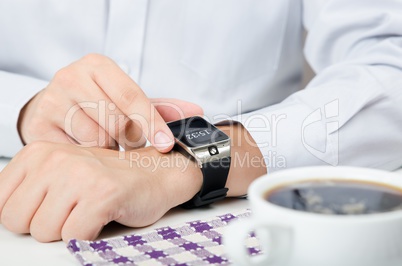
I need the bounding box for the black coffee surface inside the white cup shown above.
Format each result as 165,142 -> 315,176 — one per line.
265,179 -> 402,215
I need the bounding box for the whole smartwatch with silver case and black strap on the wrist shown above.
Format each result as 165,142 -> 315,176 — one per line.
167,116 -> 231,208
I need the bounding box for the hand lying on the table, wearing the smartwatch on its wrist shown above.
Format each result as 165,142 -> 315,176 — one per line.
0,142 -> 202,242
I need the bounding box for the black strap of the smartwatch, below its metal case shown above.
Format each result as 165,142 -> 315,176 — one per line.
182,157 -> 231,209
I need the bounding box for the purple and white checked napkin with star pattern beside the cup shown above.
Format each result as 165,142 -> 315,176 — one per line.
67,210 -> 260,266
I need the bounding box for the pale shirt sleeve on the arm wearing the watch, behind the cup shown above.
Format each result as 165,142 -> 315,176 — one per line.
236,0 -> 402,172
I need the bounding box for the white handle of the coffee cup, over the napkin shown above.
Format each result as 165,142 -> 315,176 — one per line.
223,219 -> 292,266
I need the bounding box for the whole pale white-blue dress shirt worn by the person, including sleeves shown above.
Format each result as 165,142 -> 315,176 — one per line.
0,0 -> 402,171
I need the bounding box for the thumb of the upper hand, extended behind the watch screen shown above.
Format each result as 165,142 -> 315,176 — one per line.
150,98 -> 204,122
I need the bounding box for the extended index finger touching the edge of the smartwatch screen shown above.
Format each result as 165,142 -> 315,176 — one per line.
93,61 -> 174,152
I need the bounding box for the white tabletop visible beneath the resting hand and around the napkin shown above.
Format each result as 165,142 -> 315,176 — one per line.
0,159 -> 248,266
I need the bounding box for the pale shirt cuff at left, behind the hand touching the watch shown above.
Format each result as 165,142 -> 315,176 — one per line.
0,71 -> 48,157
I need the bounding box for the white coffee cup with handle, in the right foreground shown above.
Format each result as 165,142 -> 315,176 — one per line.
223,166 -> 402,266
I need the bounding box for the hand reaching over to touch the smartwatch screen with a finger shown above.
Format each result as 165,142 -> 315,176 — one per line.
19,54 -> 203,152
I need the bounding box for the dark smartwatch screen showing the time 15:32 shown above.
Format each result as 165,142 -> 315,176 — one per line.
168,116 -> 229,148
